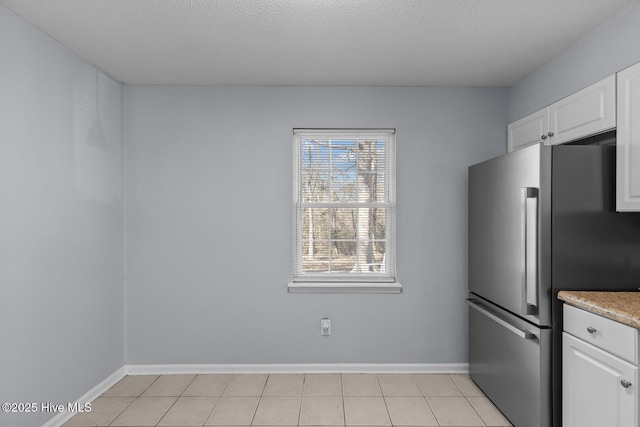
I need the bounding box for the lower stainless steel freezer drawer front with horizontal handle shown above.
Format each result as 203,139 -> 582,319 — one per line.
469,299 -> 551,427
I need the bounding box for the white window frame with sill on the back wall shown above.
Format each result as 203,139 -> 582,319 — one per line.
288,129 -> 402,293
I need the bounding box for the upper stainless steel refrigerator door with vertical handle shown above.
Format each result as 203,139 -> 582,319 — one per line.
469,144 -> 550,325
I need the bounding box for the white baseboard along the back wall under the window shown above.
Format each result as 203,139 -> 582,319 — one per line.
125,363 -> 469,375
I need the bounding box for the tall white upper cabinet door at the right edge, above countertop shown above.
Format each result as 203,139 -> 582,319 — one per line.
616,64 -> 640,211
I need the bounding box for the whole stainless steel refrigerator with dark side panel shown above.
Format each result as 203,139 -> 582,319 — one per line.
468,134 -> 640,427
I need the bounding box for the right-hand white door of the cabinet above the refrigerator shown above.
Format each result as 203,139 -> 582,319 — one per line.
545,76 -> 616,145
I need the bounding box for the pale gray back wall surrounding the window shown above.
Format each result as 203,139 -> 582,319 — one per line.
125,86 -> 508,364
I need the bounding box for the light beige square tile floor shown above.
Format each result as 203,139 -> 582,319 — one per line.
64,374 -> 511,427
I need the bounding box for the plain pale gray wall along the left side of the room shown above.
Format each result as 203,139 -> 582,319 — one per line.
0,6 -> 125,427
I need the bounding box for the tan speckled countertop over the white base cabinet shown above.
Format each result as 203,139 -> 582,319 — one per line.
558,291 -> 640,329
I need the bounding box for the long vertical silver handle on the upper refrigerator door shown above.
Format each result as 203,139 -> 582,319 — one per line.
520,187 -> 538,315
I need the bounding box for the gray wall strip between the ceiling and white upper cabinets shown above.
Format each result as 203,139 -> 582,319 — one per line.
509,5 -> 640,122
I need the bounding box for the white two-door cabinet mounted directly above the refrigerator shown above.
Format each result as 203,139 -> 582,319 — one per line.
507,76 -> 616,152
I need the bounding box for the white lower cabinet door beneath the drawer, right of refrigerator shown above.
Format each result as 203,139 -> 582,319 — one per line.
562,332 -> 639,427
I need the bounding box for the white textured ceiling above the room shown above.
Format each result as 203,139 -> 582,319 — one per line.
0,0 -> 640,86
